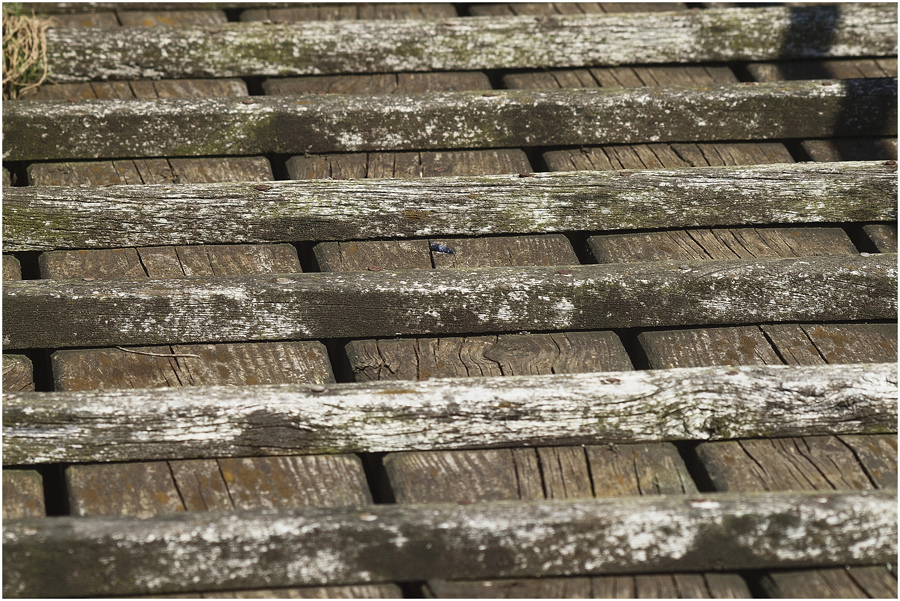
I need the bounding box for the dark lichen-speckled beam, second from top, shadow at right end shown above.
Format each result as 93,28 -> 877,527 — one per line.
3,78 -> 897,160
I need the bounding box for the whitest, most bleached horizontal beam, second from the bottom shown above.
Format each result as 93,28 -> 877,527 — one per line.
3,363 -> 897,464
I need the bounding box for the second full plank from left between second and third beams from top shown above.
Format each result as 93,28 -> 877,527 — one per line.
286,149 -> 531,180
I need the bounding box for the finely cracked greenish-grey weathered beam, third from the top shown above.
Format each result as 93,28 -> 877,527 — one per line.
3,162 -> 897,251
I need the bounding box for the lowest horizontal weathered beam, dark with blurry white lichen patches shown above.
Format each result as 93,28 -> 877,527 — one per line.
3,492 -> 897,597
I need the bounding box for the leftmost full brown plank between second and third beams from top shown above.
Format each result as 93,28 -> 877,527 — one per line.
28,157 -> 272,186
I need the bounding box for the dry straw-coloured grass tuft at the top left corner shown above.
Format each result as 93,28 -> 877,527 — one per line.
3,4 -> 54,99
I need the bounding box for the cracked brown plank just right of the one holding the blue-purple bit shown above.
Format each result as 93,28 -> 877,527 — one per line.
588,228 -> 857,263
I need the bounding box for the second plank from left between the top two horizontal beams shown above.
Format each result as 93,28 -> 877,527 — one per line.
262,71 -> 492,96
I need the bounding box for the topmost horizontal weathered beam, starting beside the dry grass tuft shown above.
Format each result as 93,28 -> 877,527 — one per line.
37,3 -> 897,82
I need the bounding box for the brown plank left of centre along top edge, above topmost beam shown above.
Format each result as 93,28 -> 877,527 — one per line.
241,2 -> 457,23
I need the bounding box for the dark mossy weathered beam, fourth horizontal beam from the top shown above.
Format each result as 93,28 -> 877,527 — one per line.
3,254 -> 897,349
